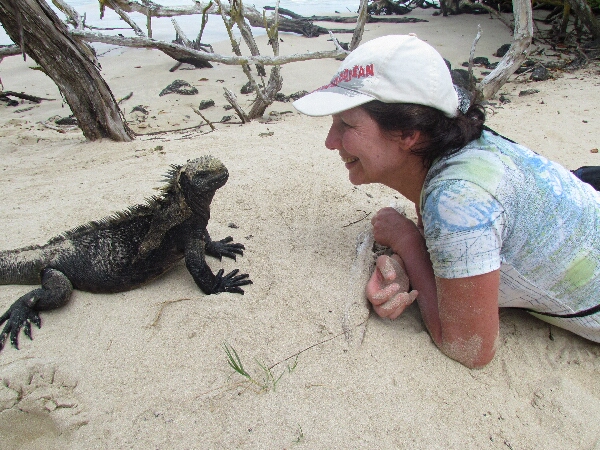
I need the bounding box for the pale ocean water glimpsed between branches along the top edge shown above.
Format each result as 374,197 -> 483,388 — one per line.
0,0 -> 360,47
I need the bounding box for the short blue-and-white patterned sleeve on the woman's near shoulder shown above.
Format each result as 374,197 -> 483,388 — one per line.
421,180 -> 505,278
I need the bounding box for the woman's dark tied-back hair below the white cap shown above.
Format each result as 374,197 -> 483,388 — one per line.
362,100 -> 485,169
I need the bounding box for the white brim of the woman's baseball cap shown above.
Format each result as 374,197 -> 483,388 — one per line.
292,86 -> 375,116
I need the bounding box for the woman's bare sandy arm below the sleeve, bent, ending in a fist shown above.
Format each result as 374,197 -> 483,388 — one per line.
371,208 -> 500,367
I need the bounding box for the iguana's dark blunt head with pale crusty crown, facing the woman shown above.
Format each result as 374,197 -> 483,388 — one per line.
176,156 -> 229,214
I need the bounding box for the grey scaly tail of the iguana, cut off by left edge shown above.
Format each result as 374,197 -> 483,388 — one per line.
0,245 -> 53,284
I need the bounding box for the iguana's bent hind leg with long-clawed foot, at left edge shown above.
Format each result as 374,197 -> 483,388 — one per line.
0,269 -> 73,350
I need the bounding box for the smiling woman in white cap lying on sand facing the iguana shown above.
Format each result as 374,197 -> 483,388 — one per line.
294,35 -> 600,367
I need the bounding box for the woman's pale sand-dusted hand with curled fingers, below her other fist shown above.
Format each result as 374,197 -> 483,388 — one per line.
366,254 -> 419,320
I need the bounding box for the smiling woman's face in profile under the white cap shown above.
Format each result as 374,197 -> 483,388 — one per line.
325,107 -> 404,186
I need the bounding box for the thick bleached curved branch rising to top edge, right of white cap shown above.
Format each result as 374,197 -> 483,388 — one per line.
477,0 -> 533,99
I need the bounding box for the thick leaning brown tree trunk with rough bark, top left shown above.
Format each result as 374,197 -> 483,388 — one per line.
0,0 -> 133,141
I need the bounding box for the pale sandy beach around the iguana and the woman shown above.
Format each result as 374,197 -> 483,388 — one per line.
0,10 -> 600,450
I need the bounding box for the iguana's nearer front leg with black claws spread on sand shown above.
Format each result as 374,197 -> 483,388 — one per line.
185,231 -> 252,295
